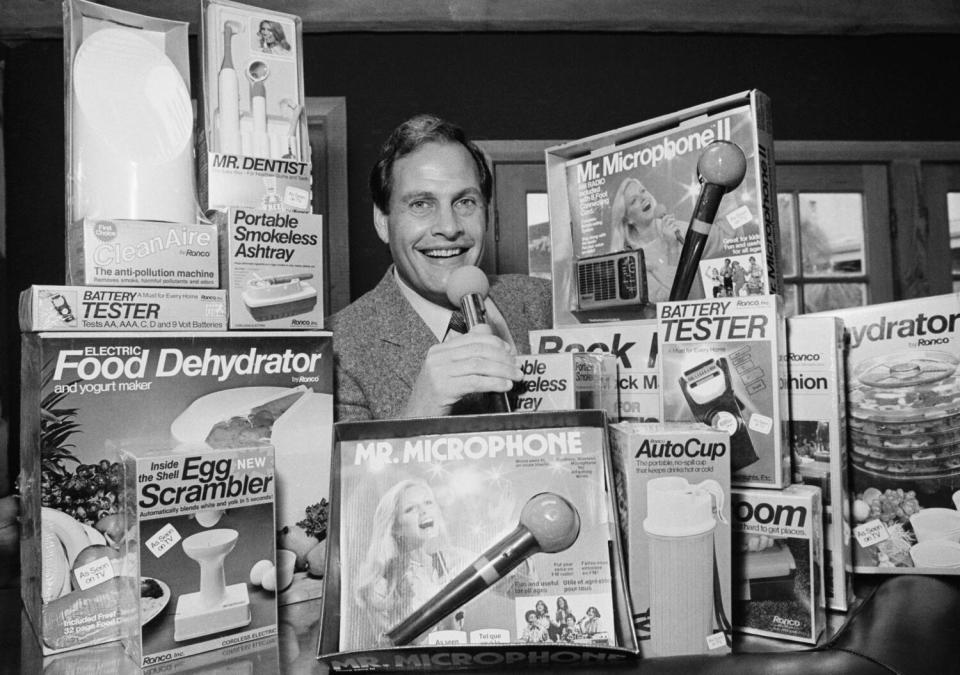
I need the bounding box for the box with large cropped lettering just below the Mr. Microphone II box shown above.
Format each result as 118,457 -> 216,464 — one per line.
530,320 -> 660,422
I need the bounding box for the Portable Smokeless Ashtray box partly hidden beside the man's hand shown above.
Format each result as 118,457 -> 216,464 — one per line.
510,352 -> 617,420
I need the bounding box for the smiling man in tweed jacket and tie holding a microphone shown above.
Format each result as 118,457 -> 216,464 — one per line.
329,115 -> 551,420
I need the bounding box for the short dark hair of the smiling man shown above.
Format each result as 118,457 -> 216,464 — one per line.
370,114 -> 493,213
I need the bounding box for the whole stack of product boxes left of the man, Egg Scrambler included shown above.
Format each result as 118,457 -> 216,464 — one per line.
20,0 -> 333,664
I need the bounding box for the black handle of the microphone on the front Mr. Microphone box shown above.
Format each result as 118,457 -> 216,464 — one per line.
387,526 -> 540,646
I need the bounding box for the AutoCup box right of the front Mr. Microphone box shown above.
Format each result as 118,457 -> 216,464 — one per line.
610,422 -> 731,657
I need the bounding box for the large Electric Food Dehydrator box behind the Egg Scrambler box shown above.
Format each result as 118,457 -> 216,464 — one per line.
20,331 -> 333,651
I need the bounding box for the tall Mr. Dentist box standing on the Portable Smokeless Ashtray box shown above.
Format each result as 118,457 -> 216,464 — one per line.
201,0 -> 311,213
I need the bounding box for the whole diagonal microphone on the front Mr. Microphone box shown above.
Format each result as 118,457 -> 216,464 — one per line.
387,492 -> 580,646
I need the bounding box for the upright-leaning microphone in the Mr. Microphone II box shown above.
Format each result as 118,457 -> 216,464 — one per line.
670,141 -> 747,300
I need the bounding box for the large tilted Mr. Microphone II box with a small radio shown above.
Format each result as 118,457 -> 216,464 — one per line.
546,90 -> 782,327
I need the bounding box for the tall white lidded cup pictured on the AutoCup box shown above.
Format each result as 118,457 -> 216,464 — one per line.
643,476 -> 726,656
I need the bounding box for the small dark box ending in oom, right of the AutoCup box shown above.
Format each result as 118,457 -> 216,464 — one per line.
733,485 -> 826,643
